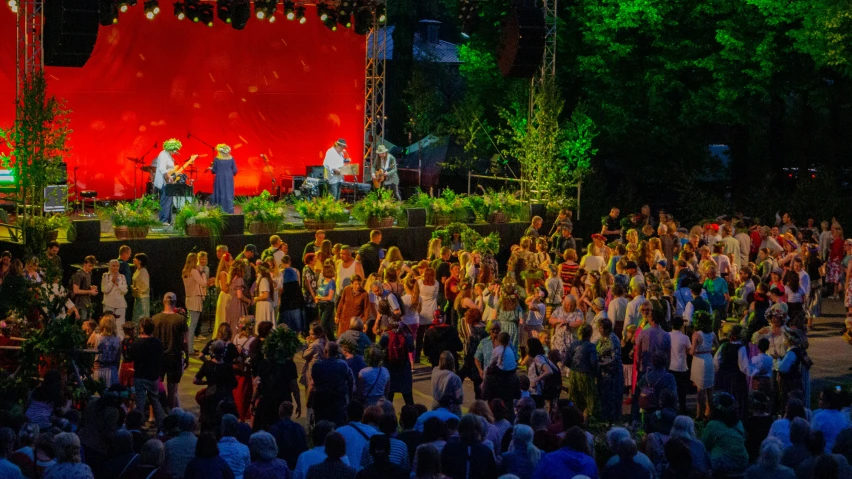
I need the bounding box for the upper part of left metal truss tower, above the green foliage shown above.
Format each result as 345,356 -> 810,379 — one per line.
15,0 -> 44,100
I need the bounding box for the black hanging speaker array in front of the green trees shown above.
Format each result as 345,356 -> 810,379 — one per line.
497,2 -> 547,78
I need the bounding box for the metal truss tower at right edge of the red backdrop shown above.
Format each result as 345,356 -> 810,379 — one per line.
364,10 -> 388,171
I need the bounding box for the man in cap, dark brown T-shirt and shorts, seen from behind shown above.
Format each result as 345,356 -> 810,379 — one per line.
152,292 -> 189,408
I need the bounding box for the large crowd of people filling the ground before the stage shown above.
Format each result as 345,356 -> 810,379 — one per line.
0,206 -> 852,479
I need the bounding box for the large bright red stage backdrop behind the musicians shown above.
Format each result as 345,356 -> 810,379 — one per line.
0,7 -> 366,198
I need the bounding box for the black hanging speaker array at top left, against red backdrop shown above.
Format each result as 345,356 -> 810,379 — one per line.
43,0 -> 100,67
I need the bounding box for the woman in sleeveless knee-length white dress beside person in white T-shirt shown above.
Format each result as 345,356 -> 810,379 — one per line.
689,311 -> 716,421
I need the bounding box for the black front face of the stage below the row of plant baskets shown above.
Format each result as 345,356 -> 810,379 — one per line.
0,222 -> 528,302
